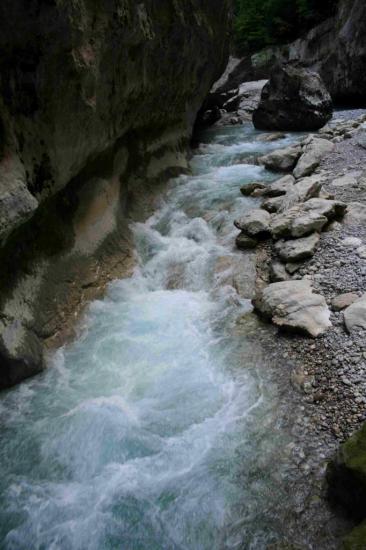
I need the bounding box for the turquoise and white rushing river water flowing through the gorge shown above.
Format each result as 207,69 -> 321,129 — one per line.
0,125 -> 338,550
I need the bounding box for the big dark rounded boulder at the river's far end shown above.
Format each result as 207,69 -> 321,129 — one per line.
253,64 -> 333,131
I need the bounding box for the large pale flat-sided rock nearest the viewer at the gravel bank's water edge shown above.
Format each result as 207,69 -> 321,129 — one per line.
254,280 -> 332,338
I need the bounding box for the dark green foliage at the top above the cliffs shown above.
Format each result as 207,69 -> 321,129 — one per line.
235,0 -> 337,54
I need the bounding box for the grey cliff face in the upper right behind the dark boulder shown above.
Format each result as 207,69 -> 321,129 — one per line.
223,0 -> 366,105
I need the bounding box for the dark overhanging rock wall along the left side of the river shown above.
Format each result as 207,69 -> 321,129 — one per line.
0,0 -> 230,387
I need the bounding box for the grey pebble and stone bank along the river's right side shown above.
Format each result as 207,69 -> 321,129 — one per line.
236,112 -> 366,548
